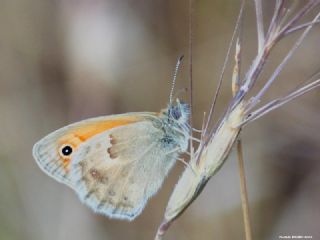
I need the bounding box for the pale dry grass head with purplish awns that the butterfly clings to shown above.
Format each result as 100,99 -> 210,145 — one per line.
155,0 -> 320,239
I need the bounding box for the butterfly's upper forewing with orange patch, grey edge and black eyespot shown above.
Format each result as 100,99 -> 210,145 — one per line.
33,113 -> 155,188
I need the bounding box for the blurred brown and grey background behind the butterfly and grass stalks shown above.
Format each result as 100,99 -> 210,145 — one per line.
0,0 -> 320,240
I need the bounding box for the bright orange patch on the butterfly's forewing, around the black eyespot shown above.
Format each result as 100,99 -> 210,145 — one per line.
57,116 -> 143,172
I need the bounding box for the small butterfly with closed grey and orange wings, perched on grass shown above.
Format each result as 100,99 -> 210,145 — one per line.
33,99 -> 190,220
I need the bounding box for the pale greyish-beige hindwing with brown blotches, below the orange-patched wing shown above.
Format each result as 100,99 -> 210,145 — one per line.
70,120 -> 178,220
